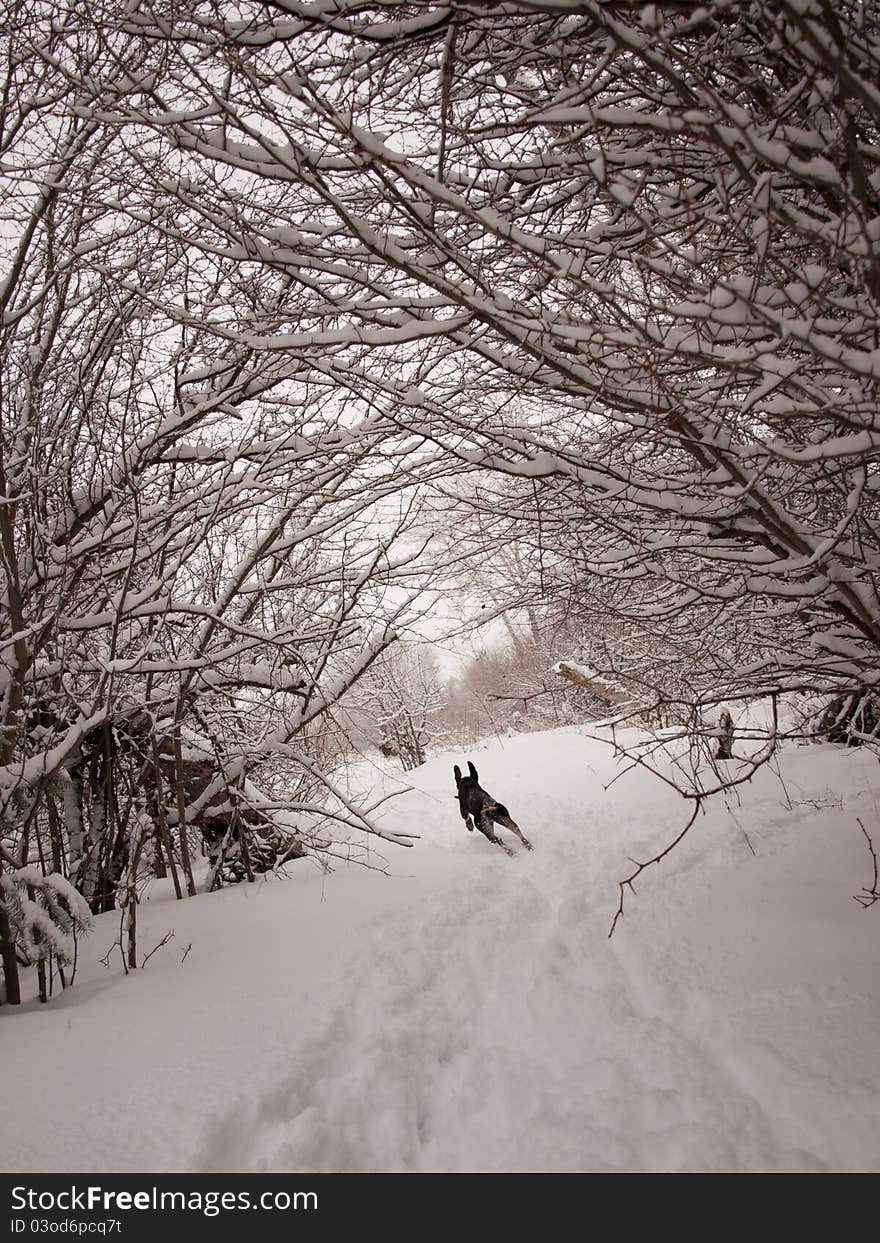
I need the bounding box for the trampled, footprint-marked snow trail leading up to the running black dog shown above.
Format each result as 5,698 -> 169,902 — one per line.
201,725 -> 878,1171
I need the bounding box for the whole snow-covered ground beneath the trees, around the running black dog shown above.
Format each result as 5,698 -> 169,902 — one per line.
0,728 -> 880,1172
